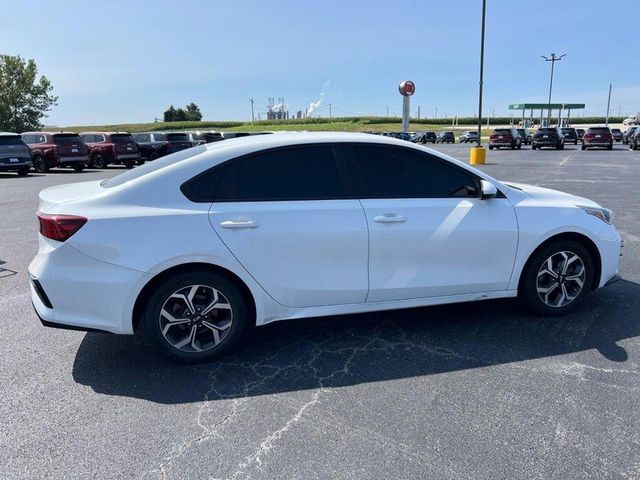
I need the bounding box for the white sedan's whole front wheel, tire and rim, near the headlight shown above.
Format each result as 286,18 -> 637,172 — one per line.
519,240 -> 594,316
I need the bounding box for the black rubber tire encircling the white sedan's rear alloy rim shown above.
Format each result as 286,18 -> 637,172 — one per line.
138,271 -> 254,363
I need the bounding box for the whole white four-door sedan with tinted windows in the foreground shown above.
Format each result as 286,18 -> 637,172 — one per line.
29,133 -> 621,361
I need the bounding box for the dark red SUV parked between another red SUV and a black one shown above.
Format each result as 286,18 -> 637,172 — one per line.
80,132 -> 142,168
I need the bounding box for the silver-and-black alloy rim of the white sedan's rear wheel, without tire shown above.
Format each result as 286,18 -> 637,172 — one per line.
158,285 -> 233,353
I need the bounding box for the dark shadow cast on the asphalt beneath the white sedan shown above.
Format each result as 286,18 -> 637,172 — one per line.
73,280 -> 640,404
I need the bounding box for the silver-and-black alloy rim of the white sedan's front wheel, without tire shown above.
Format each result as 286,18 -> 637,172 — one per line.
536,251 -> 586,308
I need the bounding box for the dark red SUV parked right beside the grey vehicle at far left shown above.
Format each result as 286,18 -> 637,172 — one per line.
22,132 -> 89,173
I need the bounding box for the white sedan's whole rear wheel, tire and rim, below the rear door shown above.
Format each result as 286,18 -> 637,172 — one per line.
142,271 -> 250,362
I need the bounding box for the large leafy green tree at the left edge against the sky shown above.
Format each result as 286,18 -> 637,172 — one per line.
0,55 -> 58,132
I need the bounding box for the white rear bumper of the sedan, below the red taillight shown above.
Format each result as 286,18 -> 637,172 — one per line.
29,236 -> 151,334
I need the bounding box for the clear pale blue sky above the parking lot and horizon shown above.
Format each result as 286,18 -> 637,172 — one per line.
0,0 -> 640,126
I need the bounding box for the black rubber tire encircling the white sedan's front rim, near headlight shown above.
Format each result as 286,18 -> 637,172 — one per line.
518,240 -> 594,317
